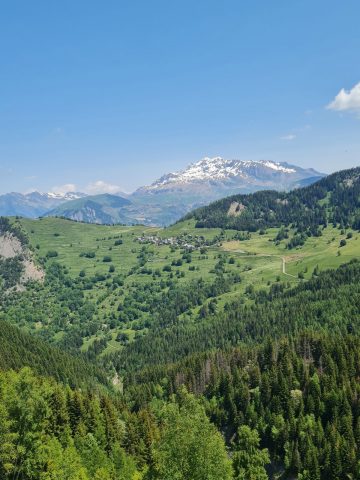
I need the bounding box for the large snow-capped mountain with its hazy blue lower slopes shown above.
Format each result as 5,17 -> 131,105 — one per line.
129,157 -> 324,225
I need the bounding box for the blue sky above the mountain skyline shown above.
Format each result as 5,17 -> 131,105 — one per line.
0,0 -> 360,192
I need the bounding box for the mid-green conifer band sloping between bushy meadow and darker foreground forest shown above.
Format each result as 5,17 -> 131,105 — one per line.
111,261 -> 360,372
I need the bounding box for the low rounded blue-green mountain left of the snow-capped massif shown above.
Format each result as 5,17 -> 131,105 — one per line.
46,193 -> 131,225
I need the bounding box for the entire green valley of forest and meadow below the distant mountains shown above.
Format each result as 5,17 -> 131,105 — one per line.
0,169 -> 360,480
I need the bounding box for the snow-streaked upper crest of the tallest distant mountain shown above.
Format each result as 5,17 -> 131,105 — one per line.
146,157 -> 301,190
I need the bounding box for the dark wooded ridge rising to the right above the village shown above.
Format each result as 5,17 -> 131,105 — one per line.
185,167 -> 360,235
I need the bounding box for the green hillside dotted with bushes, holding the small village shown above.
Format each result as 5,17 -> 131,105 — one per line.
0,212 -> 360,358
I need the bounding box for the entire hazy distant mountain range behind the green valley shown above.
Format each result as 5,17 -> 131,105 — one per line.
0,157 -> 325,225
